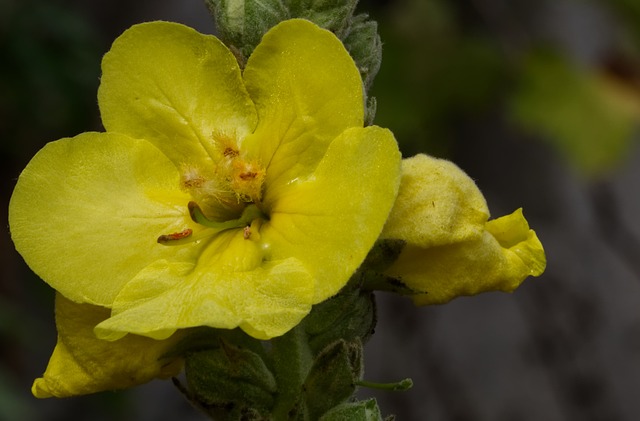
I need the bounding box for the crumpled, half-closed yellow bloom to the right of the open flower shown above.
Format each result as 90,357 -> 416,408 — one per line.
382,155 -> 546,305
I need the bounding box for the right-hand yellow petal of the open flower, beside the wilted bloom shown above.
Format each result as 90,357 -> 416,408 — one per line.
261,126 -> 400,303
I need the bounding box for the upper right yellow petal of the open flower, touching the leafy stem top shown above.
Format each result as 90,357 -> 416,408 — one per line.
243,19 -> 364,190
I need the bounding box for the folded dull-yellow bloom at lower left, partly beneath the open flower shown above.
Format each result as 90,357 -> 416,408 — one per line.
31,294 -> 182,398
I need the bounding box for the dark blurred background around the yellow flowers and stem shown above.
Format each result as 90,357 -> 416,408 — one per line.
0,0 -> 640,421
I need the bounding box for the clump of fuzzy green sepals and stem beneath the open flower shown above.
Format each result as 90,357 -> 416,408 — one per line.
168,287 -> 388,421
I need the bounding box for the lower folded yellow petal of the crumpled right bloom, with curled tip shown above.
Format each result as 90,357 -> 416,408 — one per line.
386,210 -> 546,305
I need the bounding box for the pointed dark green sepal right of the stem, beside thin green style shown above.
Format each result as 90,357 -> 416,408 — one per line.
303,339 -> 363,420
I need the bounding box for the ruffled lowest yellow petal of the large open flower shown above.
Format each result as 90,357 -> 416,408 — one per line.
96,225 -> 314,340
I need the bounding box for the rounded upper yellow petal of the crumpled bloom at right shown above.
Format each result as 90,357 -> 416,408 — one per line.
382,154 -> 489,248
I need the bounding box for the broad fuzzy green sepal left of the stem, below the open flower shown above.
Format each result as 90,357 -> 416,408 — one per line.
185,338 -> 278,420
